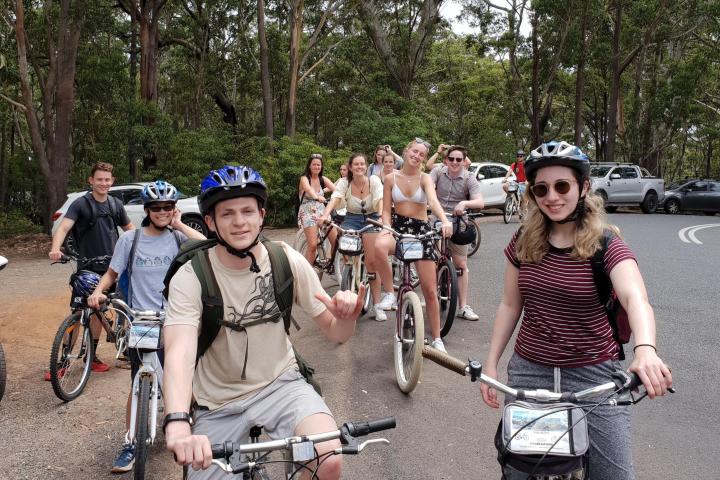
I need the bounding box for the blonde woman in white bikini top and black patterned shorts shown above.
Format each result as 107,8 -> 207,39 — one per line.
375,138 -> 452,352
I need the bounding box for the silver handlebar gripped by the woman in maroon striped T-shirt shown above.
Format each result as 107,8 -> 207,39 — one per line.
422,345 -> 675,403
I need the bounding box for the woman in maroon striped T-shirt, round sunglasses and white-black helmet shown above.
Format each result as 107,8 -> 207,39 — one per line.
481,142 -> 672,480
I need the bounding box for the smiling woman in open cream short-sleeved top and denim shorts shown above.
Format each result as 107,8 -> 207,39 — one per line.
320,153 -> 387,322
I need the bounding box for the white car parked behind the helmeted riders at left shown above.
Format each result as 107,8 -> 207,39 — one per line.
52,182 -> 208,252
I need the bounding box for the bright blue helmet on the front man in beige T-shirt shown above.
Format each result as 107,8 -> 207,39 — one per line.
198,165 -> 267,215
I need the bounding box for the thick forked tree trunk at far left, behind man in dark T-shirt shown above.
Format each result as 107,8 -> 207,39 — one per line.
15,0 -> 83,231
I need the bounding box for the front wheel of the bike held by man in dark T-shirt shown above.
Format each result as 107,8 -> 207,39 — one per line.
50,312 -> 95,402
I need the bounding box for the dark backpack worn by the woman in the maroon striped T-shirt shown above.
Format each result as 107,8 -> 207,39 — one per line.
591,230 -> 632,360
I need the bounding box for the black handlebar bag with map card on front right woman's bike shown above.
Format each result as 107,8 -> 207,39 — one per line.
495,401 -> 590,475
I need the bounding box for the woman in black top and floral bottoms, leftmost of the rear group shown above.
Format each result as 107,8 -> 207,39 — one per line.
298,153 -> 335,265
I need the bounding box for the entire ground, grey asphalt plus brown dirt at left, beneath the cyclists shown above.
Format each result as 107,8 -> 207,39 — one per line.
0,213 -> 720,480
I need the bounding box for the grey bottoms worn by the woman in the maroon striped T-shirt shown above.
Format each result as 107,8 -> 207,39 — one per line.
504,353 -> 635,480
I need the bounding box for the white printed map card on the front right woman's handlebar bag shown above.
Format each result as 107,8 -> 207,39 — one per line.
506,405 -> 571,455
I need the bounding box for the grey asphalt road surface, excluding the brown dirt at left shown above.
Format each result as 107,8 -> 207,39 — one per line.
295,213 -> 720,480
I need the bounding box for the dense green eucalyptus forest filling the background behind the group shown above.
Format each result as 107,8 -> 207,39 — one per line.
0,0 -> 720,232
